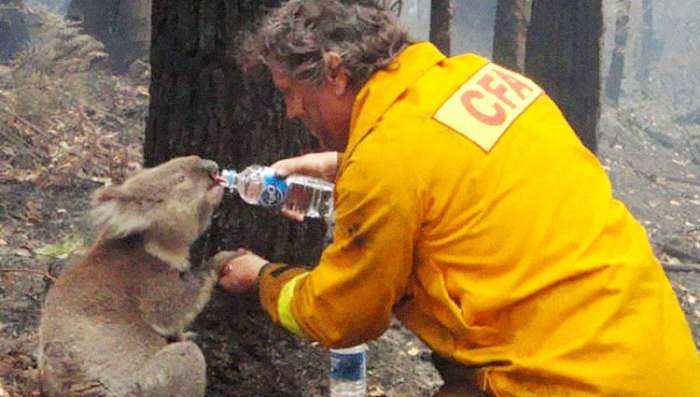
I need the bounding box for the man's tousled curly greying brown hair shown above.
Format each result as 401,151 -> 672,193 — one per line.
241,0 -> 412,88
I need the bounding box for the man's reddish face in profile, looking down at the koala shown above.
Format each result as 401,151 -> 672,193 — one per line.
270,65 -> 354,152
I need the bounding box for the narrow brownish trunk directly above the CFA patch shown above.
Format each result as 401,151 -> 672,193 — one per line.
492,0 -> 527,72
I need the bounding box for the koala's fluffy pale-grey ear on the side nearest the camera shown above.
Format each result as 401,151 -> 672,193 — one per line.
90,186 -> 151,239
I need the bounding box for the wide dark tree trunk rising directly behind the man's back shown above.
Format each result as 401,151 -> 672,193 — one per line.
525,0 -> 603,152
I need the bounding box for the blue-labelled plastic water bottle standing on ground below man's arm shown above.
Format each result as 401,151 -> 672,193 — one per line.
330,343 -> 367,397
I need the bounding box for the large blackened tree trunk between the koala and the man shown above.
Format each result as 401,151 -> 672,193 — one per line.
144,0 -> 326,397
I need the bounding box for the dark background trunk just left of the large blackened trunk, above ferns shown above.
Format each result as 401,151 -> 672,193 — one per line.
66,0 -> 151,71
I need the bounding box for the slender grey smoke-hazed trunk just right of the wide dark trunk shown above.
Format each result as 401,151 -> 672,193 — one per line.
605,0 -> 632,107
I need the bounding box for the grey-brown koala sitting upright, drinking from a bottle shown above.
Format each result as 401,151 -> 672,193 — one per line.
38,156 -> 237,397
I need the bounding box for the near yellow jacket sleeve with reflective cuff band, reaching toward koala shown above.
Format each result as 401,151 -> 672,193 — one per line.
260,138 -> 419,347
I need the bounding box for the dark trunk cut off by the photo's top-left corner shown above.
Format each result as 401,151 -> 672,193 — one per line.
0,0 -> 29,62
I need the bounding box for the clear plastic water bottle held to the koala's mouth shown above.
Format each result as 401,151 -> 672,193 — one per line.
220,165 -> 333,219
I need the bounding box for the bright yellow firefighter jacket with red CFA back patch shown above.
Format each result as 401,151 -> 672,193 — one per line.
260,43 -> 700,396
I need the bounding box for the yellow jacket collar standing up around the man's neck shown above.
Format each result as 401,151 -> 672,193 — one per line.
341,42 -> 446,169
